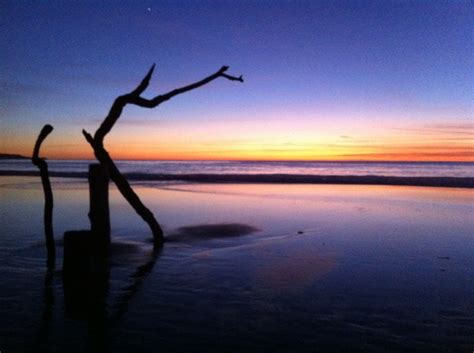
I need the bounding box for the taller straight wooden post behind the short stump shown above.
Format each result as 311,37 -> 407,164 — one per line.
89,163 -> 110,253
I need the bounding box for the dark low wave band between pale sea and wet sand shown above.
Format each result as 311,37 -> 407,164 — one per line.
0,170 -> 474,188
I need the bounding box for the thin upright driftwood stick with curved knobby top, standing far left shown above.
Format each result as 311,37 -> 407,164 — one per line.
31,125 -> 56,268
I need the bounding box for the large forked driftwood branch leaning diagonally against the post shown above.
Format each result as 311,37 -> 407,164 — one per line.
82,64 -> 244,245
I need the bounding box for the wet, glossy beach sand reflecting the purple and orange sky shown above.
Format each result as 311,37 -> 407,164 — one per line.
0,176 -> 474,352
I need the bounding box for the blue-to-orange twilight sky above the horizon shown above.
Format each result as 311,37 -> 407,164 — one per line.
0,0 -> 474,161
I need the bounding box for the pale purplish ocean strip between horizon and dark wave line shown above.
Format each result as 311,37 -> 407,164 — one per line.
0,159 -> 474,179
